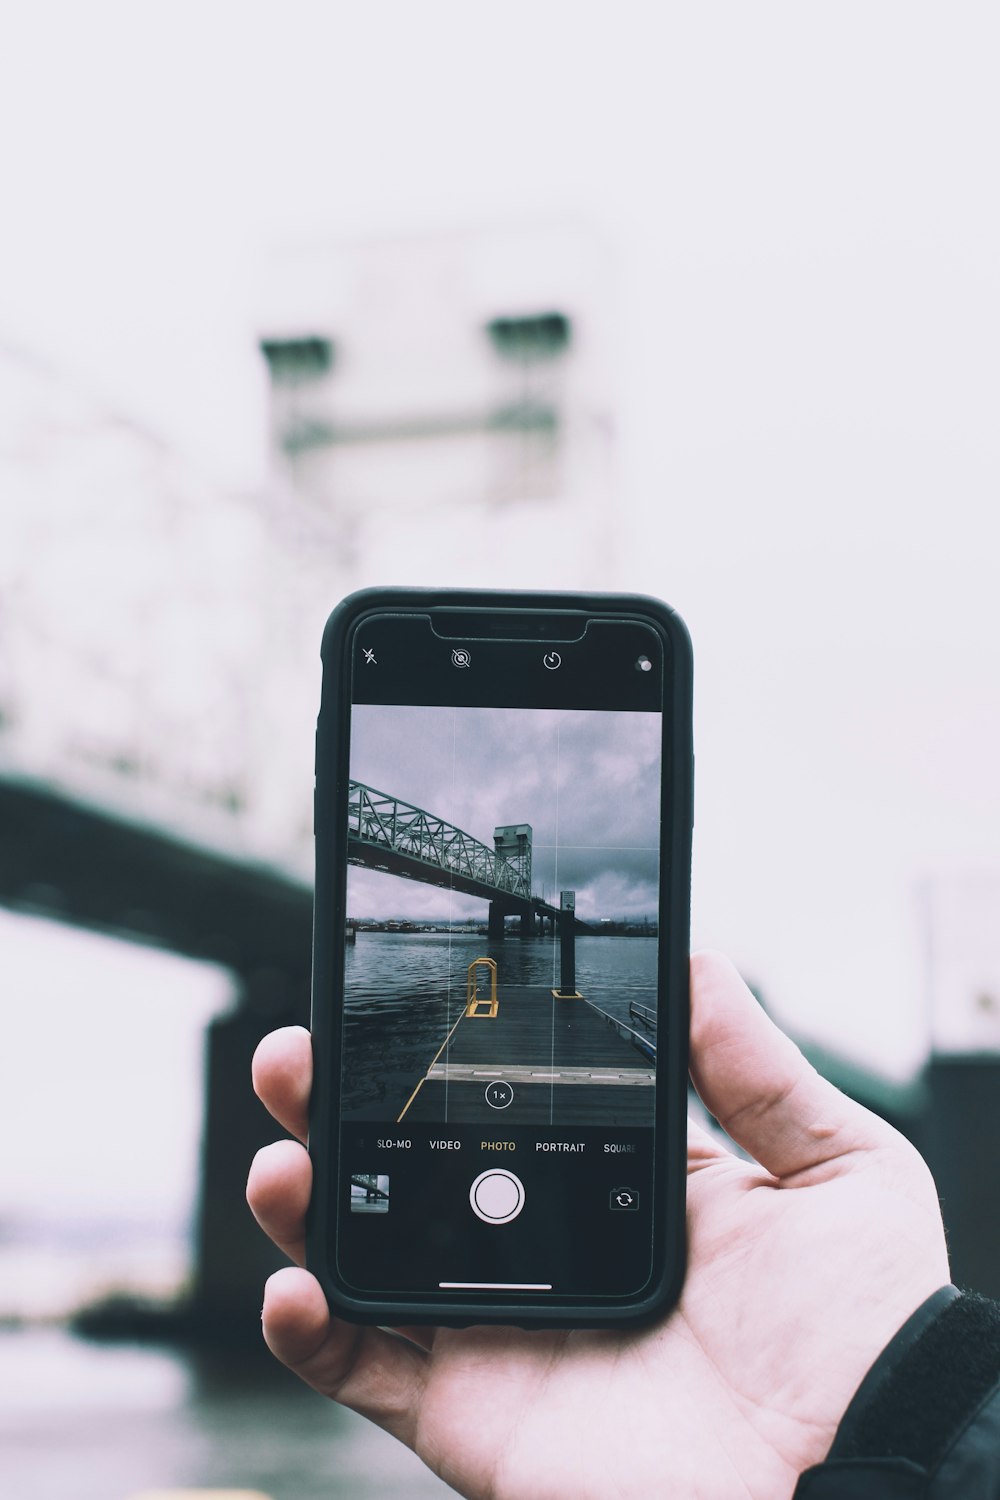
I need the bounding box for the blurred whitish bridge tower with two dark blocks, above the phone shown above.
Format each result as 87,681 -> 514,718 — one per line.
261,225 -> 618,588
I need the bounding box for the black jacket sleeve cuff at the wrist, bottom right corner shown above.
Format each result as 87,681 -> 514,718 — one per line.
795,1287 -> 1000,1500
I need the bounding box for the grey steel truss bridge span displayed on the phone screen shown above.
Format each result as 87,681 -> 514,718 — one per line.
348,782 -> 578,932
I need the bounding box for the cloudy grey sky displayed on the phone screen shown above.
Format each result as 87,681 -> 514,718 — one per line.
348,705 -> 660,921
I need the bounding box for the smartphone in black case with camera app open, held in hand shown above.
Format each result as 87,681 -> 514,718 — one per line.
307,590 -> 693,1328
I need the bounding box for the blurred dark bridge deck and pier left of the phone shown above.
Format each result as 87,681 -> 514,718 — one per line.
0,777 -> 312,1338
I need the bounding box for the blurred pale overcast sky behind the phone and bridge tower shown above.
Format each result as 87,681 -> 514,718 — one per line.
0,0 -> 1000,1266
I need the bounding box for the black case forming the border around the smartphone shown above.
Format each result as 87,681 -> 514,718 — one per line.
306,588 -> 694,1328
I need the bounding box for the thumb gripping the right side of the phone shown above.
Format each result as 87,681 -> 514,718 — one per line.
691,953 -> 898,1181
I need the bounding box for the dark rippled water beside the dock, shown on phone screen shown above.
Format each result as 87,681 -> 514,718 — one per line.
345,932 -> 657,1119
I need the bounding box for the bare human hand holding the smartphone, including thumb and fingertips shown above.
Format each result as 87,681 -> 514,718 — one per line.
247,954 -> 948,1500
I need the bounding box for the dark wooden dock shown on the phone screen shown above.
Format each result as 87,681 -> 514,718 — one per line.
399,986 -> 655,1125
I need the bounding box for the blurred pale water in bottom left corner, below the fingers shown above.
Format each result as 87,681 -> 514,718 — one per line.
0,1328 -> 454,1500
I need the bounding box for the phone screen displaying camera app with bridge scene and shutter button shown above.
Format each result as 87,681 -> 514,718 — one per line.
330,612 -> 666,1304
